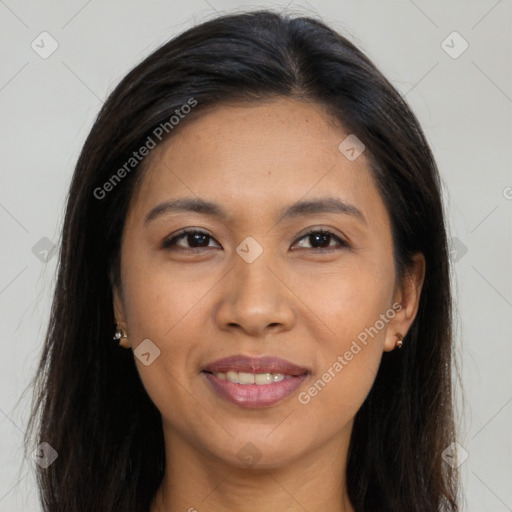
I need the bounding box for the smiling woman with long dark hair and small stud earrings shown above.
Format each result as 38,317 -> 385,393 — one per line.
25,11 -> 458,512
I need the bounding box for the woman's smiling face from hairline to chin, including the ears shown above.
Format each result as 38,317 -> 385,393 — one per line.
114,99 -> 422,467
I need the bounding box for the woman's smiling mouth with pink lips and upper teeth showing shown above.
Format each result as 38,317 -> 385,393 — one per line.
201,356 -> 310,408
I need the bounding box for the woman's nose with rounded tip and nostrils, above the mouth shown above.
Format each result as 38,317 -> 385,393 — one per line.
215,251 -> 296,337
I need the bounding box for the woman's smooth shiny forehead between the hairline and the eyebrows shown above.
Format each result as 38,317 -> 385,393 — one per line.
127,99 -> 385,228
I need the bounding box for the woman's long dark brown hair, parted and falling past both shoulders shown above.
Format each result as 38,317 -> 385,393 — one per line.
26,11 -> 458,512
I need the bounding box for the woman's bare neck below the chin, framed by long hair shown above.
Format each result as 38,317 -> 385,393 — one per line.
150,429 -> 354,512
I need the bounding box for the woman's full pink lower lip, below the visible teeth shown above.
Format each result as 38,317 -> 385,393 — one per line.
202,372 -> 307,409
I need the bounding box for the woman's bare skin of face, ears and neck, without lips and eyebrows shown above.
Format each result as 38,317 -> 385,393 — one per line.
114,98 -> 425,512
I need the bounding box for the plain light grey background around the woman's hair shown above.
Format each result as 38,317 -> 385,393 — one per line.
0,0 -> 512,512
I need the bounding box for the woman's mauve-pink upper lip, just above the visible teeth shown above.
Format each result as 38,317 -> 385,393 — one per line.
203,355 -> 309,375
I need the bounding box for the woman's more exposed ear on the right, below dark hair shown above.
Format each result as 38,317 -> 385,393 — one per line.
384,253 -> 426,352
